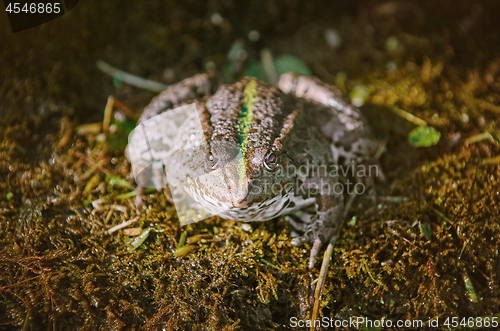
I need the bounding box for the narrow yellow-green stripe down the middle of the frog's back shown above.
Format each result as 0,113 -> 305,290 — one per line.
237,79 -> 257,186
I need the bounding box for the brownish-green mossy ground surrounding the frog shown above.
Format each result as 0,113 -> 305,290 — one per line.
0,1 -> 500,330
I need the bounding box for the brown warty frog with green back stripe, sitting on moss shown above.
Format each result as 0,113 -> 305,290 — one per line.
129,72 -> 378,269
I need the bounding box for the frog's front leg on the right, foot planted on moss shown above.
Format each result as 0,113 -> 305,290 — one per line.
291,177 -> 344,269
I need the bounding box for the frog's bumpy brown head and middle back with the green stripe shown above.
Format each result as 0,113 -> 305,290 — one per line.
192,78 -> 299,209
